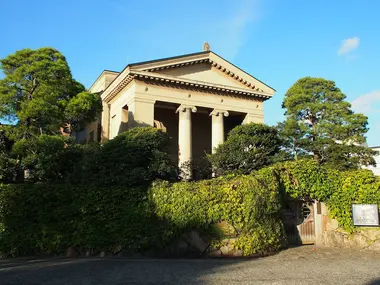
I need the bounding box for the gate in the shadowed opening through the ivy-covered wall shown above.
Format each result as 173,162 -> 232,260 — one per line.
284,201 -> 315,245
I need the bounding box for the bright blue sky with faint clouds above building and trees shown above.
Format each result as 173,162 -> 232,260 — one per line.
0,0 -> 380,146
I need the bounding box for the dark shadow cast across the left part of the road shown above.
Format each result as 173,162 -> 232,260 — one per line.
0,258 -> 252,284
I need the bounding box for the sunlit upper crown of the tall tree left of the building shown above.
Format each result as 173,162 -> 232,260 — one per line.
0,48 -> 100,139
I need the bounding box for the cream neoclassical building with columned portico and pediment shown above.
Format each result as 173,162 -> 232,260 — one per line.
86,44 -> 275,176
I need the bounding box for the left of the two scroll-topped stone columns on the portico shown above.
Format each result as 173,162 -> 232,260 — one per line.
176,105 -> 197,180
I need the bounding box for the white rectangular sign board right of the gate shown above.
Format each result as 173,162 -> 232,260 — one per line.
352,204 -> 379,226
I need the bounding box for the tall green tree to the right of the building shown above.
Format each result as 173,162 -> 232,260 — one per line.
280,77 -> 375,169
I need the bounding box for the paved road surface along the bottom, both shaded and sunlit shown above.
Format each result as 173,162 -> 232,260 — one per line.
0,246 -> 380,285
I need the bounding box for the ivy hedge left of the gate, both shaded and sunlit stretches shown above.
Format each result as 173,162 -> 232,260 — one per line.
0,166 -> 284,256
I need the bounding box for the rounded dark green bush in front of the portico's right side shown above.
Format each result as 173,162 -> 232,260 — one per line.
209,123 -> 281,175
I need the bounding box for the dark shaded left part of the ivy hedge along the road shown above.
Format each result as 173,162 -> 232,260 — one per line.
0,184 -> 170,256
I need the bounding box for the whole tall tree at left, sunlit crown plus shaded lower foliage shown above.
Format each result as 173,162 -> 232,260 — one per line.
0,48 -> 101,182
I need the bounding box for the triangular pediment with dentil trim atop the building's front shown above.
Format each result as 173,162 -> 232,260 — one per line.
130,52 -> 275,95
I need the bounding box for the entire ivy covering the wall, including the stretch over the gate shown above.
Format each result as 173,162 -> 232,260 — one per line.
0,160 -> 380,256
